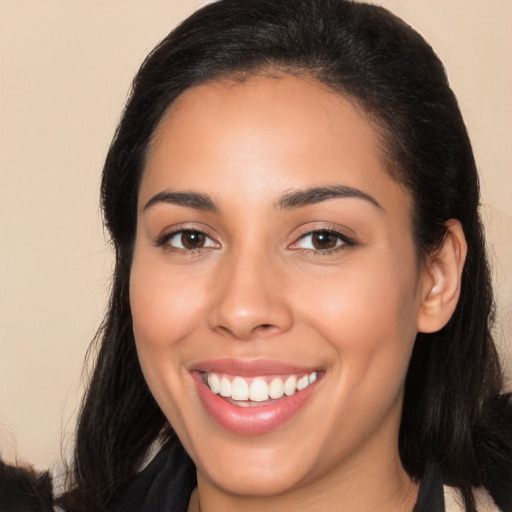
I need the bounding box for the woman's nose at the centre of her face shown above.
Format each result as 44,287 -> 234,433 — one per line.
208,251 -> 293,340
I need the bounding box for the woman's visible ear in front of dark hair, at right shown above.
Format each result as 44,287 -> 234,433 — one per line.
417,219 -> 468,333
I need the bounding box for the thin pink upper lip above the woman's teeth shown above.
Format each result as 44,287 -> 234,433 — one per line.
189,359 -> 319,377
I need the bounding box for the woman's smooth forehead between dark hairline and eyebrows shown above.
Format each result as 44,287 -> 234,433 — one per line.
140,74 -> 408,217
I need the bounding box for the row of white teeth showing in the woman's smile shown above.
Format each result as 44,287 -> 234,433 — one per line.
203,372 -> 318,405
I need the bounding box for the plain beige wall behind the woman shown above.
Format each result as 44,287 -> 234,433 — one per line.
0,0 -> 512,467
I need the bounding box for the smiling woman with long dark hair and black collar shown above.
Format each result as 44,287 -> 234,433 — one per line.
54,0 -> 512,512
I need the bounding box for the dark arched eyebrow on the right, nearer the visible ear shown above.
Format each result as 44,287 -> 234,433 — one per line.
276,185 -> 384,211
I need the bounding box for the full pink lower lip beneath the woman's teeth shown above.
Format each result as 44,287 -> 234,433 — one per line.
195,376 -> 318,436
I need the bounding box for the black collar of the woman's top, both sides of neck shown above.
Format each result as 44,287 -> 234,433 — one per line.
111,440 -> 445,512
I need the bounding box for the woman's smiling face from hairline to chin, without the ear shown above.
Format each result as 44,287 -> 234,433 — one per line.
130,75 -> 426,494
